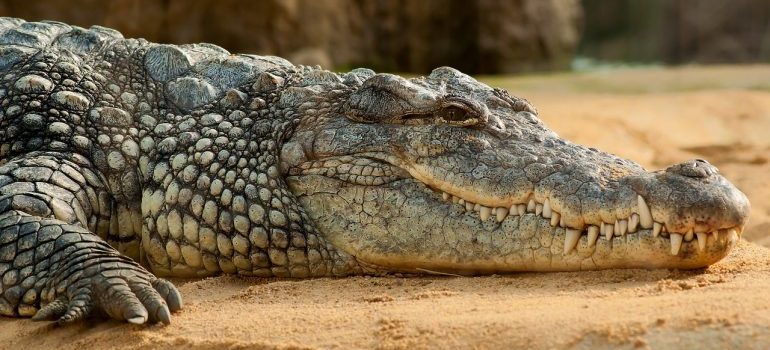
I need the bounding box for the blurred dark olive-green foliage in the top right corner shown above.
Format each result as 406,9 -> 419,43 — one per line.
577,0 -> 770,64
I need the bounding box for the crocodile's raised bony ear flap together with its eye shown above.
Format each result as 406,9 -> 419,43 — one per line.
344,73 -> 488,126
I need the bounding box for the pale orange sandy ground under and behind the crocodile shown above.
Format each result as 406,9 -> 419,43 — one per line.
0,66 -> 770,349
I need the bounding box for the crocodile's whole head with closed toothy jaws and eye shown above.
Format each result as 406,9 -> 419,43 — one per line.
281,68 -> 750,274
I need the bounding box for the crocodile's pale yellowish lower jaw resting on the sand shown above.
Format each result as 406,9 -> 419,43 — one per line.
289,177 -> 738,275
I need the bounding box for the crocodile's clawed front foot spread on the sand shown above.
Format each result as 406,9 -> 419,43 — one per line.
32,262 -> 182,325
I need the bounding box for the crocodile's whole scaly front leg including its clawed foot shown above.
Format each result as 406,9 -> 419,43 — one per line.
0,153 -> 182,323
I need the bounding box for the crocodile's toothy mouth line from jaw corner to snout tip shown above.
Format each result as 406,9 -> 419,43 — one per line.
289,152 -> 743,256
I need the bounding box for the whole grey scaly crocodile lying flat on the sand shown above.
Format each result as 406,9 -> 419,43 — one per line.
0,18 -> 750,324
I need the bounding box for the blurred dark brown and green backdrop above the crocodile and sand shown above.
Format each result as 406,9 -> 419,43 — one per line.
0,0 -> 770,74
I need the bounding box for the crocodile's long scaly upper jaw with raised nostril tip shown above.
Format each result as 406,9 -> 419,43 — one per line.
376,123 -> 750,255
